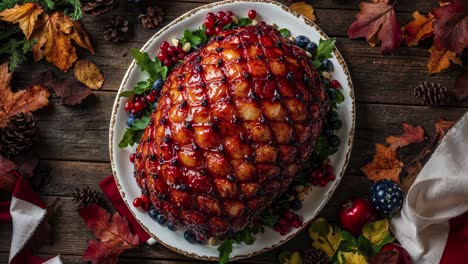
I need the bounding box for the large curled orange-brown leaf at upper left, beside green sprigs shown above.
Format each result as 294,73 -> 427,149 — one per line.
31,12 -> 94,72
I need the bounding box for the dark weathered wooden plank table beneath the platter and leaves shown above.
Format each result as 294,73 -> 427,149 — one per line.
0,0 -> 468,264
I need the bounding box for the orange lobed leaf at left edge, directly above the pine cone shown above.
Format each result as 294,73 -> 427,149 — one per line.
0,63 -> 50,128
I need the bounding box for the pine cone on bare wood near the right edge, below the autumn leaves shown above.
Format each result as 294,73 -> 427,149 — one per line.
414,82 -> 447,106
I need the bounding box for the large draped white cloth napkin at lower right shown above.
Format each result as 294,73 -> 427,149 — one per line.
390,112 -> 468,263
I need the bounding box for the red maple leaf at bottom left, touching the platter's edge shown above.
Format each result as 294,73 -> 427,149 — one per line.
79,204 -> 139,264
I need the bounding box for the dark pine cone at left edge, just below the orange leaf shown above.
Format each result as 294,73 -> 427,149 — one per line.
0,113 -> 38,156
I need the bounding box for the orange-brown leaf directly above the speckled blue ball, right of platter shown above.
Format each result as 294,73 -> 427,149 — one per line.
361,144 -> 403,183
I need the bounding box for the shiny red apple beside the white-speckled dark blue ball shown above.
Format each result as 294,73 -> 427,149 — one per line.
340,198 -> 376,236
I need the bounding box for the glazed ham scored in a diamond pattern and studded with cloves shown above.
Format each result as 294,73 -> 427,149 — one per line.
135,25 -> 329,238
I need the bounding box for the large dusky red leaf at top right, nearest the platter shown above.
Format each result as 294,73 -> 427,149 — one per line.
348,0 -> 403,54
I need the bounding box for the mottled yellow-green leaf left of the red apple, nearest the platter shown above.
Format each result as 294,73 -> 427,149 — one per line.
309,218 -> 343,259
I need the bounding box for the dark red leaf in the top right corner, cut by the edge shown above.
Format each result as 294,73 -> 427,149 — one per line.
432,0 -> 468,54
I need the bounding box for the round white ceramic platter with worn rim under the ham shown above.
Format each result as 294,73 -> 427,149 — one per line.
109,0 -> 355,260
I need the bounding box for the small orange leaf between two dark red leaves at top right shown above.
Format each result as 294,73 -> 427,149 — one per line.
403,11 -> 435,46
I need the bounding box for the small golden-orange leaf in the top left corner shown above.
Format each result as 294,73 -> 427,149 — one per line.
0,3 -> 43,39
